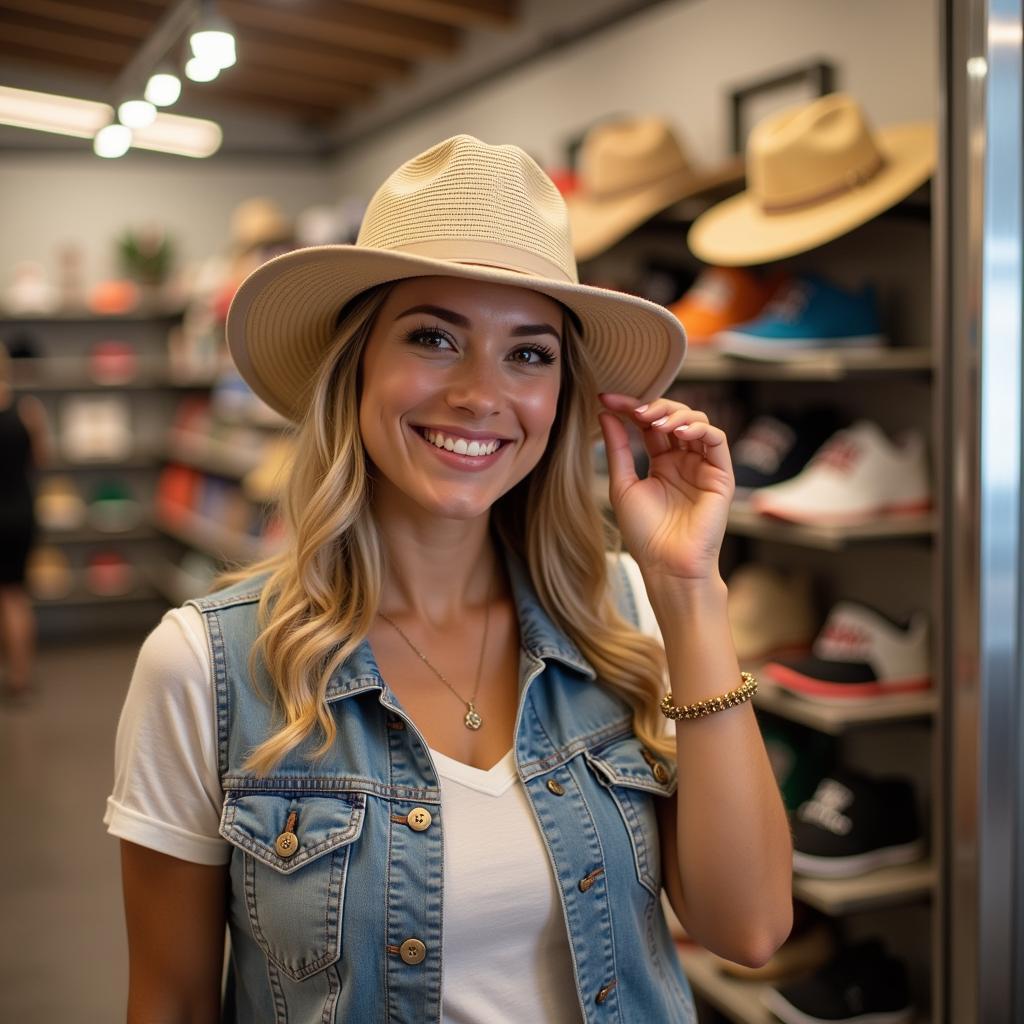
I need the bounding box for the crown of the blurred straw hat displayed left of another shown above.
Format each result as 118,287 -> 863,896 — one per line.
580,117 -> 692,199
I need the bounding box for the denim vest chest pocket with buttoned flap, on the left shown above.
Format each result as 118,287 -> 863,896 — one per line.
220,792 -> 366,981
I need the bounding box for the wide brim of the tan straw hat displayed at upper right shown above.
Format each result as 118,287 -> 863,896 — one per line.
686,124 -> 936,266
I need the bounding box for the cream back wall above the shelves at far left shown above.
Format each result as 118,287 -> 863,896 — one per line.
0,151 -> 336,290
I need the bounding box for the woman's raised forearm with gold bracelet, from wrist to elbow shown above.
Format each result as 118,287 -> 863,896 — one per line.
648,580 -> 793,966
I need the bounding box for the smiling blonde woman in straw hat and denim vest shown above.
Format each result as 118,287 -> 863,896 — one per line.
104,135 -> 792,1024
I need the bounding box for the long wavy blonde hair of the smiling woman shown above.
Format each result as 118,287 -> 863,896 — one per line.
211,285 -> 675,775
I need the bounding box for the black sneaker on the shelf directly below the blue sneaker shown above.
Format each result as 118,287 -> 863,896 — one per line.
732,407 -> 842,500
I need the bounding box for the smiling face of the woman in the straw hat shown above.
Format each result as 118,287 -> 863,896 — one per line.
359,276 -> 562,519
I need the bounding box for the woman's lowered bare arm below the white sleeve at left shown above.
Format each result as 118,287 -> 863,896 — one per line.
121,840 -> 228,1024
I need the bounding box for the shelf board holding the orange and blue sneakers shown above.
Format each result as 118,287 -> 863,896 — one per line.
676,345 -> 935,383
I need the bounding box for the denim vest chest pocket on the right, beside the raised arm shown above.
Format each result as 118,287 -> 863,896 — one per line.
586,734 -> 676,896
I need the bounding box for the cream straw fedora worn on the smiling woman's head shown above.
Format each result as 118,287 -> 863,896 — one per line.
226,135 -> 686,427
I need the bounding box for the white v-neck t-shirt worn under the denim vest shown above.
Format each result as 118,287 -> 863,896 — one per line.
103,554 -> 664,1024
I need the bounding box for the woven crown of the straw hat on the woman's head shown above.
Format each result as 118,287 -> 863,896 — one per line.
355,135 -> 579,284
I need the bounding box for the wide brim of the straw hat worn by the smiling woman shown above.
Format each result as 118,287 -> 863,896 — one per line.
226,245 -> 686,425
